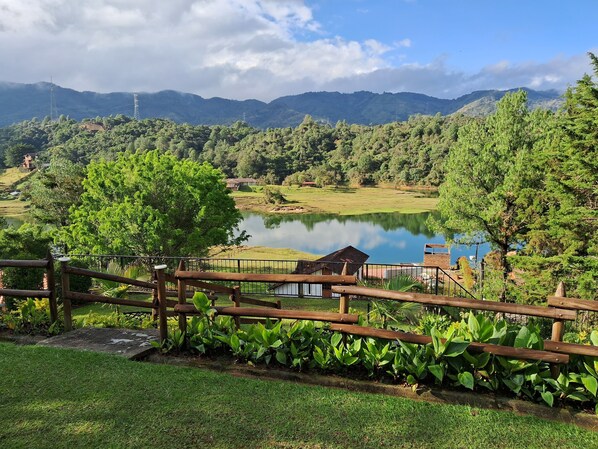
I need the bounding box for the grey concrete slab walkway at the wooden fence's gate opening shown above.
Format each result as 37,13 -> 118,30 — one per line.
38,327 -> 159,359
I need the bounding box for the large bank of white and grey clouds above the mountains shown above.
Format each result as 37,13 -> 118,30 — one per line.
0,0 -> 589,100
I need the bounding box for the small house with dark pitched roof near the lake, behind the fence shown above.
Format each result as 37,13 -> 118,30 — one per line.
271,246 -> 370,298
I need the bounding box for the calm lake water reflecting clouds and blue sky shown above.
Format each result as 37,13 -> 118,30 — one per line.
240,212 -> 489,263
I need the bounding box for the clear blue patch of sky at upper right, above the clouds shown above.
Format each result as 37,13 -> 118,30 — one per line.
308,0 -> 598,70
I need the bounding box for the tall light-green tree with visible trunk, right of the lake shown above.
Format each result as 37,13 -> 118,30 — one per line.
437,91 -> 540,299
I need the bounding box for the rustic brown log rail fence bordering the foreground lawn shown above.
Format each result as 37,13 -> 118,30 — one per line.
0,255 -> 598,375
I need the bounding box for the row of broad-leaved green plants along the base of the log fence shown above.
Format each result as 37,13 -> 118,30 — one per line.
158,313 -> 598,407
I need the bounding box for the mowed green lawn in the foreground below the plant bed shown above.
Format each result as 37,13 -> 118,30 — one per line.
0,343 -> 598,449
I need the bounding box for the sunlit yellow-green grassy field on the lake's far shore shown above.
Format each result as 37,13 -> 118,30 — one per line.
233,187 -> 438,215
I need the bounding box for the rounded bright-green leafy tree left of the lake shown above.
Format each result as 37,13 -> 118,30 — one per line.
60,150 -> 245,257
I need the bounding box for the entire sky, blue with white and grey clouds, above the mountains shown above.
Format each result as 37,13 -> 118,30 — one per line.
0,0 -> 598,101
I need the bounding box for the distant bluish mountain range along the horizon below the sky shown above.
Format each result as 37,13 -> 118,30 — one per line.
0,82 -> 562,129
